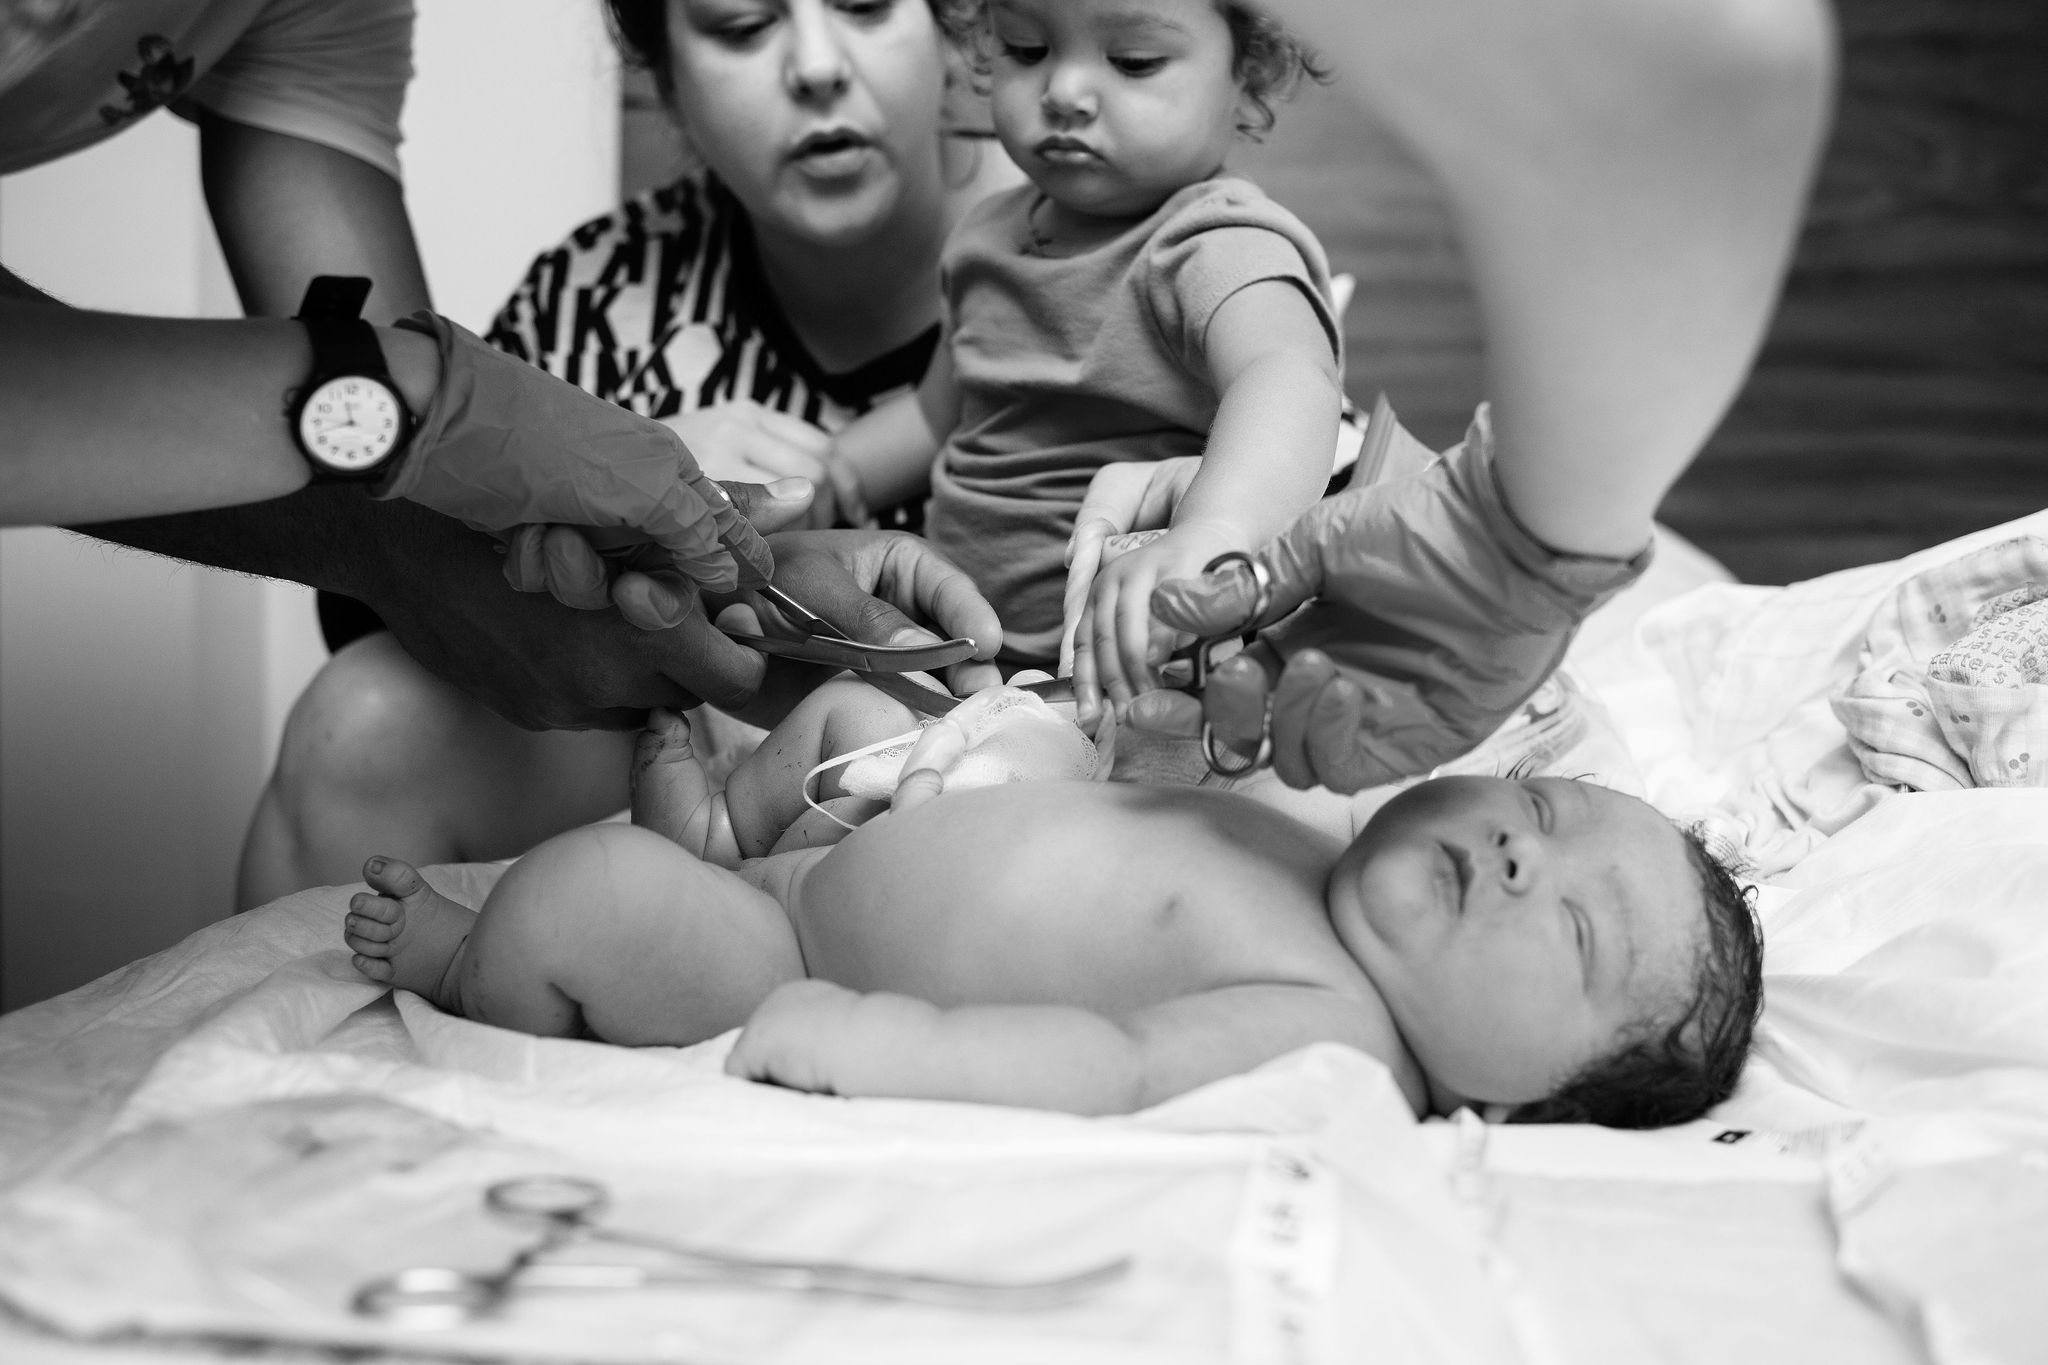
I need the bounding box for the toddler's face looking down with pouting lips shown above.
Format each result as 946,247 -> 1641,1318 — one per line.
991,0 -> 1239,217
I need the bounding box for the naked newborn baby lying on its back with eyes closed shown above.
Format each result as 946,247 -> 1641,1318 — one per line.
346,688 -> 1761,1128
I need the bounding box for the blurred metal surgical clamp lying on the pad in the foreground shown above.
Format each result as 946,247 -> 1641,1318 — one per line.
354,1175 -> 1130,1330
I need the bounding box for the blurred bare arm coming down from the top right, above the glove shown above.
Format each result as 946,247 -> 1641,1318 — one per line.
1268,0 -> 1833,557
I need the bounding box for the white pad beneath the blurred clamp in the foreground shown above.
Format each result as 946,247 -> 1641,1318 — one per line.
0,868 -> 1516,1365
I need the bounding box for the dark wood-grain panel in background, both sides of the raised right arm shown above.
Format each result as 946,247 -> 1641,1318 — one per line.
1237,0 -> 2048,583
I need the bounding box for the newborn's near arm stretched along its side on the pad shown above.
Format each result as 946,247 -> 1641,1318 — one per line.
725,980 -> 1391,1113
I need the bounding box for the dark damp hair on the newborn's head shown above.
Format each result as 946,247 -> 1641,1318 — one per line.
1507,829 -> 1763,1128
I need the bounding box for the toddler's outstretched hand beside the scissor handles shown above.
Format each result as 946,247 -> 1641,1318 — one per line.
1073,524 -> 1245,724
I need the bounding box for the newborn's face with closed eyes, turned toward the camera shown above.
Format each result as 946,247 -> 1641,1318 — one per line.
1327,778 -> 1706,1105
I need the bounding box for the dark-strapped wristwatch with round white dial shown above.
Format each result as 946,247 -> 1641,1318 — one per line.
289,274 -> 412,483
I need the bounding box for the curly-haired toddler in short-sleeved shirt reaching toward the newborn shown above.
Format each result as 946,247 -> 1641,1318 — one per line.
827,0 -> 1343,700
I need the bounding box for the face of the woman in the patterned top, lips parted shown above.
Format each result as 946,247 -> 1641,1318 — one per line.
668,0 -> 946,246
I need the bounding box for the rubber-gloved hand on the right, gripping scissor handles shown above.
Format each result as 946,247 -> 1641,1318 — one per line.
1128,409 -> 1651,792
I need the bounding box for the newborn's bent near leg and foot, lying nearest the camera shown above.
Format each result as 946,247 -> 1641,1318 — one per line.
339,825 -> 803,1046
